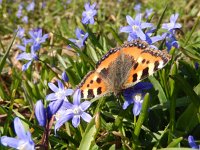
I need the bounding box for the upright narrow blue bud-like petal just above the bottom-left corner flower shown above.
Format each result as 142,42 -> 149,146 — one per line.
35,100 -> 47,127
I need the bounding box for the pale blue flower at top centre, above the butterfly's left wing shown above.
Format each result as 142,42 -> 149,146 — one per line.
82,3 -> 97,24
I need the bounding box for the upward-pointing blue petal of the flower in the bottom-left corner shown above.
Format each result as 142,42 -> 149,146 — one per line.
14,117 -> 26,139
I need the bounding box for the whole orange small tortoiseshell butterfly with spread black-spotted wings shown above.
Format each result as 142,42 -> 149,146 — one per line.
77,40 -> 171,99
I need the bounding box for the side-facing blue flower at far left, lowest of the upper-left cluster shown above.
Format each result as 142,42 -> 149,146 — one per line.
17,50 -> 38,71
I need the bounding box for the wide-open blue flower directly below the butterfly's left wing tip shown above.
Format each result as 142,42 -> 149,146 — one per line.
55,89 -> 92,132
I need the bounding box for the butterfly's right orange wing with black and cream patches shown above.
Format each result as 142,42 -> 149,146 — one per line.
122,41 -> 171,89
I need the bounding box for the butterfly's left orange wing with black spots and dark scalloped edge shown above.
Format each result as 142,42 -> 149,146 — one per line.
77,49 -> 119,99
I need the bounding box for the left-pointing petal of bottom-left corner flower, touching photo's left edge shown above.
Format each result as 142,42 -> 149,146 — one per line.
1,136 -> 20,148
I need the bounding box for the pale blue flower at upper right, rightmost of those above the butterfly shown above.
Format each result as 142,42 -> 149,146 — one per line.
162,14 -> 181,31
